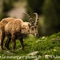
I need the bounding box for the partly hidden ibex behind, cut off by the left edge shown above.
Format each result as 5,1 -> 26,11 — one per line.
0,17 -> 14,51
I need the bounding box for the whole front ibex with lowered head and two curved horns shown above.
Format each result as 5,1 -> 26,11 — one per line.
5,13 -> 38,50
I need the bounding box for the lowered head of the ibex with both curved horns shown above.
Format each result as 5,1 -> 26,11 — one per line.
24,13 -> 38,36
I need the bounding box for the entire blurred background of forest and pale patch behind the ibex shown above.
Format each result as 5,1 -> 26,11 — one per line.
0,0 -> 60,36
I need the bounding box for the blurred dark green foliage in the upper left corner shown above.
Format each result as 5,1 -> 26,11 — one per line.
0,0 -> 14,20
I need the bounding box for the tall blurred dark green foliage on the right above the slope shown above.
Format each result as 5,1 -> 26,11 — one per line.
43,0 -> 60,34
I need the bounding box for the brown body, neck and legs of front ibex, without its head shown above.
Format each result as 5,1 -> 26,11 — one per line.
5,19 -> 29,50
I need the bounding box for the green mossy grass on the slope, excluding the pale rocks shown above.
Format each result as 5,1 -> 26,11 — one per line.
0,32 -> 60,60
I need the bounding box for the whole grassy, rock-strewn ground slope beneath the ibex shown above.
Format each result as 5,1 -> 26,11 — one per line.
0,32 -> 60,60
